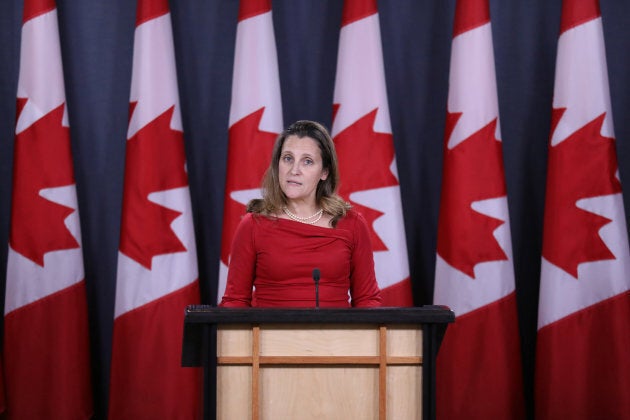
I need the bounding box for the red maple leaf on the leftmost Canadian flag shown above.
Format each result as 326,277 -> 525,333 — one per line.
9,98 -> 79,267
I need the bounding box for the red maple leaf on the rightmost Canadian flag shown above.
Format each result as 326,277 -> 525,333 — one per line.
543,108 -> 621,278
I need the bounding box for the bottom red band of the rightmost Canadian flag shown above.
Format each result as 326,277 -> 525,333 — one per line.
535,292 -> 630,420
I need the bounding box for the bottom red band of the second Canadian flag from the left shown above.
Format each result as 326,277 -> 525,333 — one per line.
109,281 -> 202,419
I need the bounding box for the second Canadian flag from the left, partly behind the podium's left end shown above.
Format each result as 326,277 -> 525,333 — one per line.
109,0 -> 202,419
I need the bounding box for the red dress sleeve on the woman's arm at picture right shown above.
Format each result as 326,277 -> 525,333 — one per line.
350,213 -> 381,308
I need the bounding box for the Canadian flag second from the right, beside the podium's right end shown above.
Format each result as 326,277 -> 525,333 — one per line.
433,0 -> 525,419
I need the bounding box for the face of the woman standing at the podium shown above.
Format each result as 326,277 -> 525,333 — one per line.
278,135 -> 328,205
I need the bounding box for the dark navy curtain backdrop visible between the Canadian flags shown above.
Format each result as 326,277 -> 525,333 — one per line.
0,0 -> 630,418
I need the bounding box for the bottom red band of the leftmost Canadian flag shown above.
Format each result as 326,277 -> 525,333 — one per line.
4,281 -> 93,419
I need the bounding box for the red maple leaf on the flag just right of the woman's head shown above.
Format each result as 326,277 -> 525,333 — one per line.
334,108 -> 398,251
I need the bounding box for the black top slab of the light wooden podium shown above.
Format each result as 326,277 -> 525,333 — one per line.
184,305 -> 455,325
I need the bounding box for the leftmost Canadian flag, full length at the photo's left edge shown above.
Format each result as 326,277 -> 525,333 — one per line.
3,0 -> 93,419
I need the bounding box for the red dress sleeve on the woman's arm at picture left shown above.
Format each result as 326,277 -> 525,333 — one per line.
219,213 -> 256,307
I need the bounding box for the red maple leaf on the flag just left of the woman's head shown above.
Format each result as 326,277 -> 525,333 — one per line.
221,107 -> 278,264
